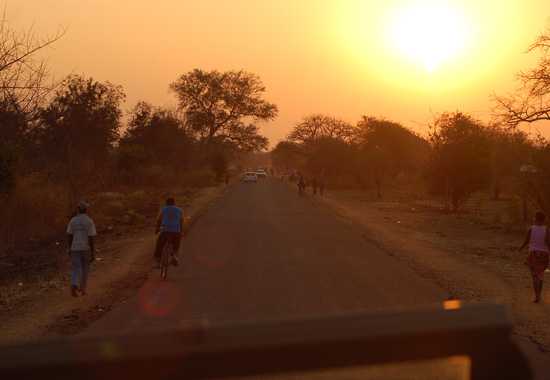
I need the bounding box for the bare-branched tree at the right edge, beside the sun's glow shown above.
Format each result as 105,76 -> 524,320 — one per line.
494,28 -> 550,127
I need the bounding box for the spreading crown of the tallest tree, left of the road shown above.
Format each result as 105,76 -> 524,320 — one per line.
170,69 -> 278,151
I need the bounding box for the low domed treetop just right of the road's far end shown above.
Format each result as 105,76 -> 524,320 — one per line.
288,114 -> 355,144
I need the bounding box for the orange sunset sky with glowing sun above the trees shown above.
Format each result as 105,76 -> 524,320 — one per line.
9,0 -> 550,144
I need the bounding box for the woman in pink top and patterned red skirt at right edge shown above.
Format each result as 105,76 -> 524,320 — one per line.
519,211 -> 550,303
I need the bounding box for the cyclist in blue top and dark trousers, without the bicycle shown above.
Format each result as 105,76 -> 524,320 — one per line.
155,198 -> 183,267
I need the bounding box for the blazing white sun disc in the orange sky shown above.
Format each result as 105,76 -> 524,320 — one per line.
389,4 -> 469,73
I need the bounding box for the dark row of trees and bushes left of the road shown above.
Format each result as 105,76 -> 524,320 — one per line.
0,69 -> 277,250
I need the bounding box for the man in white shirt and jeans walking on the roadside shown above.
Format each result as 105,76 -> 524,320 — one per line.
67,202 -> 97,297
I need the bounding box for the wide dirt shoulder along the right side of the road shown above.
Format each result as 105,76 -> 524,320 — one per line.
314,191 -> 550,370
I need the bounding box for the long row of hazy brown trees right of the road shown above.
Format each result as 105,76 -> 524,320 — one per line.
272,112 -> 550,211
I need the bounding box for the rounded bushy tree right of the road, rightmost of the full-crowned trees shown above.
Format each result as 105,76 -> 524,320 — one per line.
428,112 -> 491,211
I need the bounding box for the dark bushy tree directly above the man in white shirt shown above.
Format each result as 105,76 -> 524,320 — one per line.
40,76 -> 124,203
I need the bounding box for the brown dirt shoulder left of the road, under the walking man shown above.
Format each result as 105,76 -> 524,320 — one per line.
0,187 -> 224,344
